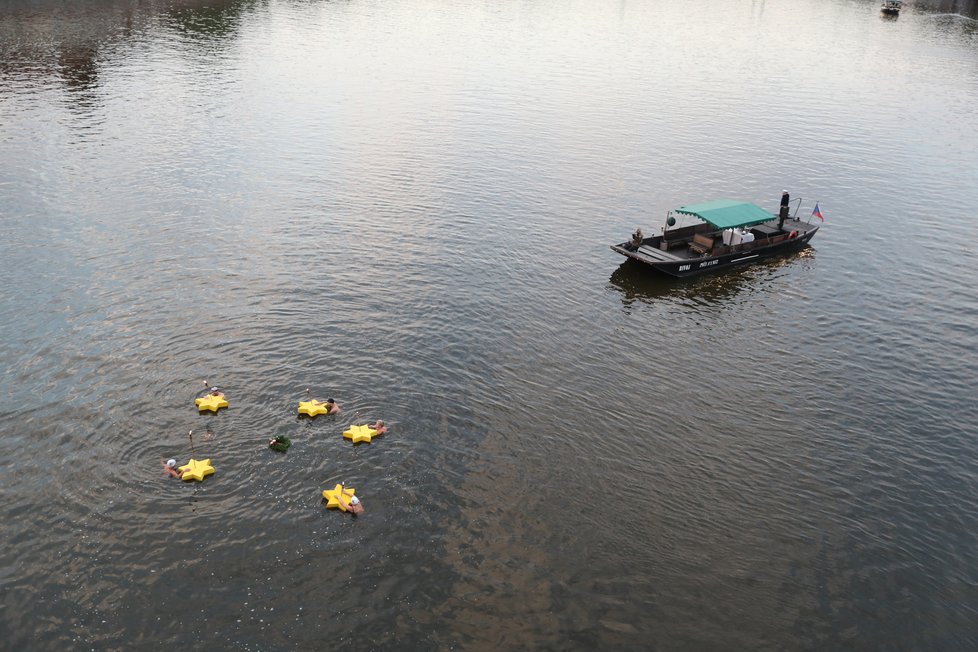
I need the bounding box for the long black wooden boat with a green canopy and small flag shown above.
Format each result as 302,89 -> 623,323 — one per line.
611,199 -> 820,277
